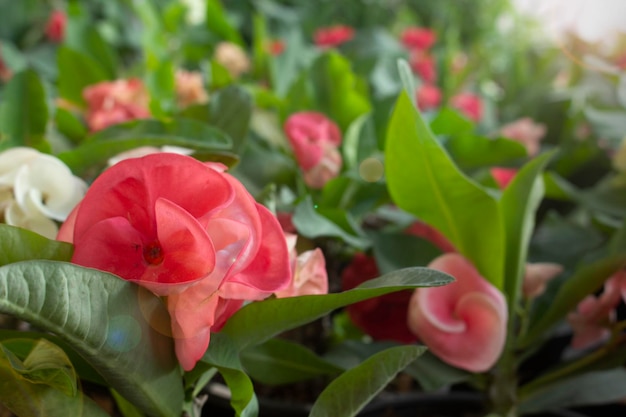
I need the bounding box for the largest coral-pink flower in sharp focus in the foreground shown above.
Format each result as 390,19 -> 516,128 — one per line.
57,153 -> 291,370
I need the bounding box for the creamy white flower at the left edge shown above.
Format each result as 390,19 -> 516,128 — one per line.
0,147 -> 87,239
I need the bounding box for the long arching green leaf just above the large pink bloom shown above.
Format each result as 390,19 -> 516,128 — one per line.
57,119 -> 236,176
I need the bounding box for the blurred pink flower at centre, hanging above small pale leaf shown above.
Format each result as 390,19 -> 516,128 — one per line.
285,112 -> 343,188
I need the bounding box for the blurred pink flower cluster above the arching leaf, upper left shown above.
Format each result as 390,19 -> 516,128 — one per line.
83,78 -> 150,132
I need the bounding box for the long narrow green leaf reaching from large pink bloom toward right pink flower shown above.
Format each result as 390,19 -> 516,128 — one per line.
217,267 -> 453,350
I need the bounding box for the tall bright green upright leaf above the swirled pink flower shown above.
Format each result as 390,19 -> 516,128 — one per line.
385,92 -> 505,288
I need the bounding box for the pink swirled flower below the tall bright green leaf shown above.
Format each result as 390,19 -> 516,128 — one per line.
408,253 -> 508,372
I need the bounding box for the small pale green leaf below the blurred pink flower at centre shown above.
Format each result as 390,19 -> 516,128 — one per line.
293,196 -> 369,249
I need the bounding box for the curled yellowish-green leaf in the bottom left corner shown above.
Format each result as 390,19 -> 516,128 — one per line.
0,340 -> 107,417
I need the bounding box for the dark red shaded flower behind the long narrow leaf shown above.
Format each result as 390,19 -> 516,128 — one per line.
341,253 -> 417,343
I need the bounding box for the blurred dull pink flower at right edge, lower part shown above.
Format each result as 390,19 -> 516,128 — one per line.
567,270 -> 626,349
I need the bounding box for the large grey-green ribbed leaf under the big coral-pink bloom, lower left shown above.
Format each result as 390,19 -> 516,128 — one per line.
0,261 -> 183,416
